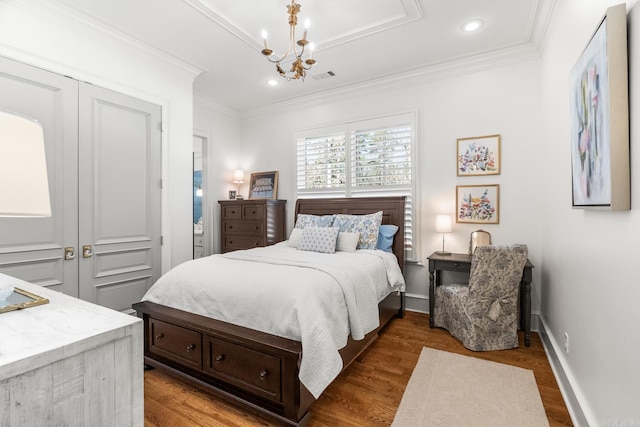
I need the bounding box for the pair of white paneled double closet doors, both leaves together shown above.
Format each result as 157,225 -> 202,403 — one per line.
0,57 -> 161,311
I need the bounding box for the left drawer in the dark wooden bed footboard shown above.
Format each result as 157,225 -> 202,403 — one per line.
149,318 -> 202,369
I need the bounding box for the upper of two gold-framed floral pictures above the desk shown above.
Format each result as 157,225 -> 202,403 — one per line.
456,135 -> 501,176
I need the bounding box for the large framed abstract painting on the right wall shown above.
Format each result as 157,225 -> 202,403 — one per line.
569,4 -> 631,210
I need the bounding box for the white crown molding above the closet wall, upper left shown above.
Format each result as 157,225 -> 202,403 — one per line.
0,0 -> 206,82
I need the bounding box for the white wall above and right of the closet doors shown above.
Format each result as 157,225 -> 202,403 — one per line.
0,0 -> 200,271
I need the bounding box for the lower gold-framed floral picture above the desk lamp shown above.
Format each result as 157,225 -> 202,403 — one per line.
456,184 -> 500,224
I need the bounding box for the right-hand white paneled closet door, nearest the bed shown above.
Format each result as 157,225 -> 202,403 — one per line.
78,83 -> 161,311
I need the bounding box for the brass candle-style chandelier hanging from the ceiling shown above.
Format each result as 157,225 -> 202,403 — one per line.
262,0 -> 316,80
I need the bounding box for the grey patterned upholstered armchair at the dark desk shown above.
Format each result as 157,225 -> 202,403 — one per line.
433,245 -> 528,351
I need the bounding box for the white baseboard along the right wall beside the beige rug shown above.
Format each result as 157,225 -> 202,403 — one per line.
538,316 -> 597,427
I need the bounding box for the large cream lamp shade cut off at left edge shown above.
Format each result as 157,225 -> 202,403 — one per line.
0,111 -> 51,217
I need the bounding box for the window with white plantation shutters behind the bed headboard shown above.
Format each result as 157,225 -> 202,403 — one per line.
295,113 -> 416,259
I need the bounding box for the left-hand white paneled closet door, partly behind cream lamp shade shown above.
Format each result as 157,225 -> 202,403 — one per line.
0,57 -> 78,296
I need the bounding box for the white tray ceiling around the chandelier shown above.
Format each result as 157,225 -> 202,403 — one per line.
57,0 -> 558,111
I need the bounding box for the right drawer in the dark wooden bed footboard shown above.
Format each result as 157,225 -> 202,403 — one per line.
205,336 -> 281,402
